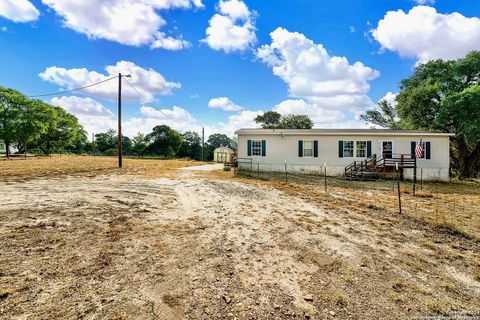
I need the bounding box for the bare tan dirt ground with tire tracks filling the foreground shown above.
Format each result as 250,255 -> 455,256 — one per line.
0,157 -> 480,319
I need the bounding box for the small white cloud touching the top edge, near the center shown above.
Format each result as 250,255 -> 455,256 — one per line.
202,0 -> 257,53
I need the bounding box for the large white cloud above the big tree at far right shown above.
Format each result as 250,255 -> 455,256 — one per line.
372,6 -> 480,63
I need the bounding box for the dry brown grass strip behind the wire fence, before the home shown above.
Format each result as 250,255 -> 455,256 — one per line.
238,174 -> 480,239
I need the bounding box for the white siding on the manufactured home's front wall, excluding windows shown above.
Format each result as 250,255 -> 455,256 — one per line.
238,134 -> 450,180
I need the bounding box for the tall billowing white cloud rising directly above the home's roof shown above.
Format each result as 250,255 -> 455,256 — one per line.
257,28 -> 379,126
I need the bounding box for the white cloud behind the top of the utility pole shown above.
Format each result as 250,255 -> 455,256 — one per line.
39,61 -> 181,100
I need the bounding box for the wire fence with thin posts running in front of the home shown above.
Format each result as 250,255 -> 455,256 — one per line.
235,159 -> 480,237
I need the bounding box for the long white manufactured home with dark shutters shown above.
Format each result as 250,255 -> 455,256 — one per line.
235,129 -> 452,181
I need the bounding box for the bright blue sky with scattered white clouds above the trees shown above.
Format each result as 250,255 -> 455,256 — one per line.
0,0 -> 480,136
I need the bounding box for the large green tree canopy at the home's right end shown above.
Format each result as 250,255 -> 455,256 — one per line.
362,51 -> 480,178
